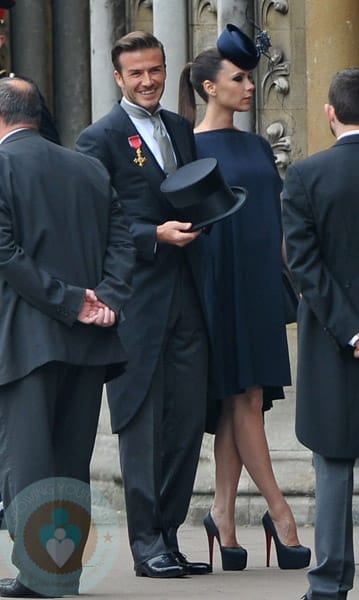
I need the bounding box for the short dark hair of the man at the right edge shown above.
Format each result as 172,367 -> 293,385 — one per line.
328,67 -> 359,125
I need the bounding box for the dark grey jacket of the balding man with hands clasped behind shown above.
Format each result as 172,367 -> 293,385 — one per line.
0,129 -> 133,384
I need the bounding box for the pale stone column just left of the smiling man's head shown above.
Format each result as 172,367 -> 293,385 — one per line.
90,0 -> 119,121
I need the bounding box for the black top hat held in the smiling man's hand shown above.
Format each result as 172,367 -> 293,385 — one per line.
161,158 -> 247,231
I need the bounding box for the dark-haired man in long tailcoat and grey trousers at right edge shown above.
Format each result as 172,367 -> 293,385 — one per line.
283,67 -> 359,600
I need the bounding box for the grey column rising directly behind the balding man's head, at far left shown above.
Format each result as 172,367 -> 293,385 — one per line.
10,0 -> 52,106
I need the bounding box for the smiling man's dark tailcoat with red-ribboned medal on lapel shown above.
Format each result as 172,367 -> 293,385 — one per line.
76,104 -> 205,432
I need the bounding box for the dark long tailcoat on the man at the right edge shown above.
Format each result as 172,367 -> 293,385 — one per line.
283,132 -> 359,458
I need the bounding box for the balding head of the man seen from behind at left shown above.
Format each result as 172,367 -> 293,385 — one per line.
0,77 -> 41,128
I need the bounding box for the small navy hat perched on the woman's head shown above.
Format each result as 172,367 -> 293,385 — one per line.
217,23 -> 261,71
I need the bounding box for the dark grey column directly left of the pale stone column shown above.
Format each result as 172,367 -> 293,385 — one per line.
53,0 -> 91,148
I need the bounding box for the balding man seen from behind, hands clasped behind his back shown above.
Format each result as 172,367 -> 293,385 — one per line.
0,78 -> 135,597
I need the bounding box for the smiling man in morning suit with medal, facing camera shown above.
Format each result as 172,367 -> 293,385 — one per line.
77,31 -> 209,577
